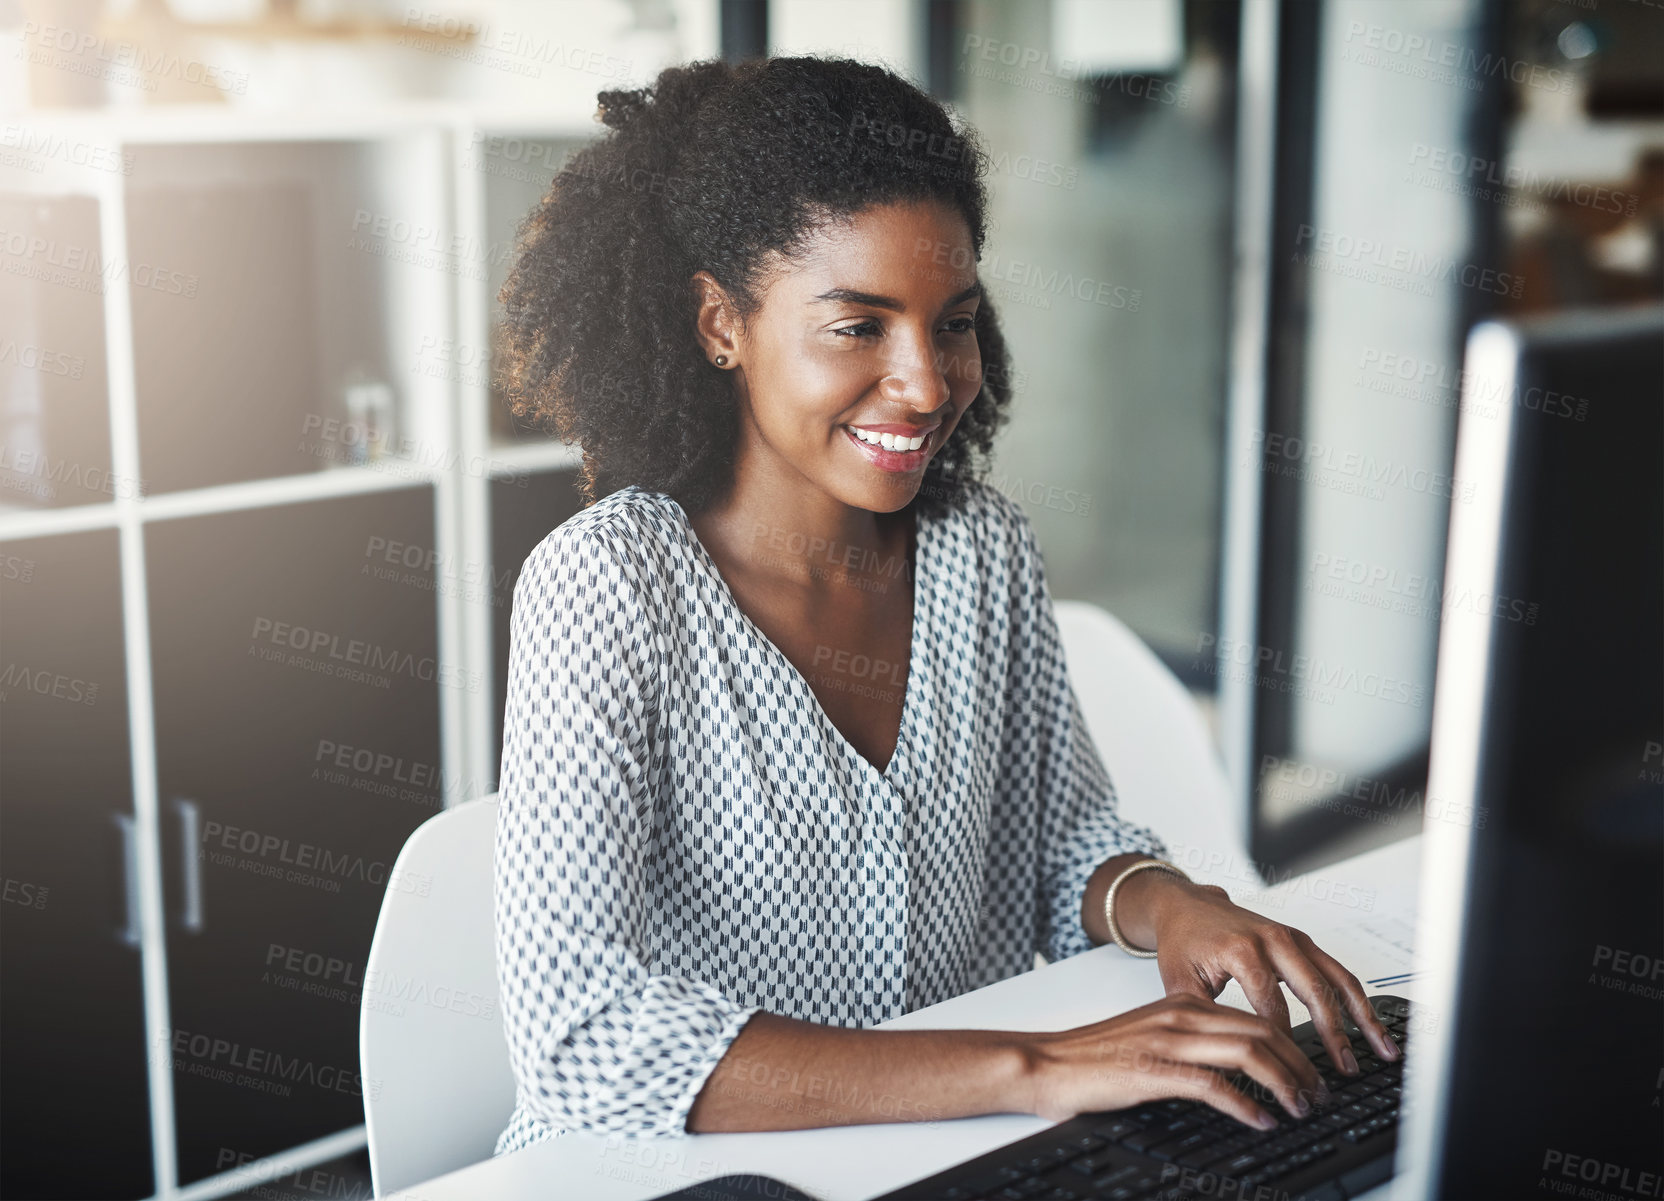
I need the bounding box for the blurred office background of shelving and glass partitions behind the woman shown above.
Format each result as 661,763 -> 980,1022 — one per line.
0,0 -> 1664,1198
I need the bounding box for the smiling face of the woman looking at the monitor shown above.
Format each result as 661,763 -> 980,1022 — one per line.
708,203 -> 982,512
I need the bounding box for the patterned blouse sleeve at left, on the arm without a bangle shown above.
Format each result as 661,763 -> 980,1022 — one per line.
494,526 -> 759,1136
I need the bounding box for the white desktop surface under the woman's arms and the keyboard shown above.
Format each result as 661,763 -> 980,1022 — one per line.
394,837 -> 1421,1201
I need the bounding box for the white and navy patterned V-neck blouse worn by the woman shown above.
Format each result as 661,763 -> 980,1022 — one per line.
494,484 -> 1165,1154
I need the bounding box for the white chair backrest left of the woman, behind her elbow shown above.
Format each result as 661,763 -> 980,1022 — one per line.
358,797 -> 514,1198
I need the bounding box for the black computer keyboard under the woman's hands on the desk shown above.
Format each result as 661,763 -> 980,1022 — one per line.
875,996 -> 1409,1201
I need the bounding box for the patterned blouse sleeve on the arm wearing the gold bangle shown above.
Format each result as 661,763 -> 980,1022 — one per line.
985,502 -> 1166,963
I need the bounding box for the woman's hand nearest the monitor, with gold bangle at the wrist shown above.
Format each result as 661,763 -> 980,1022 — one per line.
1117,872 -> 1401,1076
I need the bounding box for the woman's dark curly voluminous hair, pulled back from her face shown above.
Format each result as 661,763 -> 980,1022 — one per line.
499,58 -> 1010,511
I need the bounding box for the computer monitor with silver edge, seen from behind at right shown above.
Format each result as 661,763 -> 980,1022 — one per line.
1393,308 -> 1664,1199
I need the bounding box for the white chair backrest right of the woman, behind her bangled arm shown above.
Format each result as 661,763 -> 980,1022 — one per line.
1055,601 -> 1240,878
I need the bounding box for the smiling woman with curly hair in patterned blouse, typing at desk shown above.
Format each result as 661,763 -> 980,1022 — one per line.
496,58 -> 1398,1151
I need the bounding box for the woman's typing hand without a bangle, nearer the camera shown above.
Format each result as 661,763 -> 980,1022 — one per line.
1023,993 -> 1328,1129
